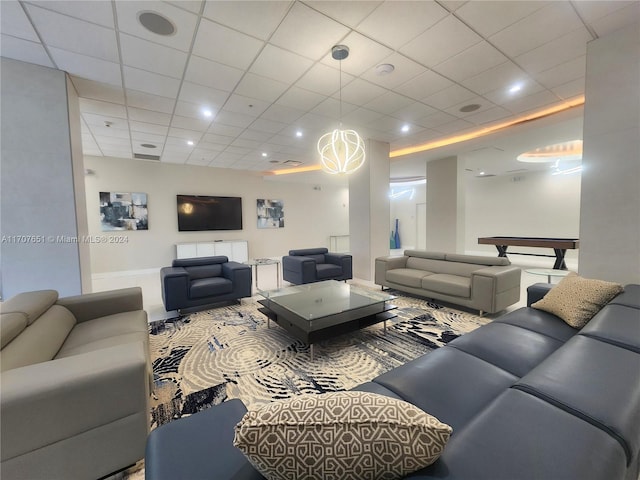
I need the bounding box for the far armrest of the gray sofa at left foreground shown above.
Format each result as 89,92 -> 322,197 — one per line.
57,287 -> 143,322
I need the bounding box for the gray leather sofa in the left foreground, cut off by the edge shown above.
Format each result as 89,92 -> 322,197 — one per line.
0,288 -> 152,480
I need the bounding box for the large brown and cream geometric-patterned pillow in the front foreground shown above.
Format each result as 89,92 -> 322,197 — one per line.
233,392 -> 452,480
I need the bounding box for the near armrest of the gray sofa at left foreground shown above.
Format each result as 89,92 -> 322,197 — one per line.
0,342 -> 149,462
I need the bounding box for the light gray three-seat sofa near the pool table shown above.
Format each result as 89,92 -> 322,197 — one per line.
375,250 -> 521,315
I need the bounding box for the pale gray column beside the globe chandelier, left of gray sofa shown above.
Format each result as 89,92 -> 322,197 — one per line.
349,140 -> 390,280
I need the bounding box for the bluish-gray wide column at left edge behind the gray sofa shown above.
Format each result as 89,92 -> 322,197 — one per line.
0,58 -> 90,299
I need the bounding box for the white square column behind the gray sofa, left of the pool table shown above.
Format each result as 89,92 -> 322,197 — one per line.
426,157 -> 465,253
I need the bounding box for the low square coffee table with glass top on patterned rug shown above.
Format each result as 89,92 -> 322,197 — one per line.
258,280 -> 397,360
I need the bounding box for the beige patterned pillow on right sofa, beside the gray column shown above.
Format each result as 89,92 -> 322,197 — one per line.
531,272 -> 623,328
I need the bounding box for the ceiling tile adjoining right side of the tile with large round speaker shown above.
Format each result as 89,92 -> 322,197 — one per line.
193,19 -> 264,69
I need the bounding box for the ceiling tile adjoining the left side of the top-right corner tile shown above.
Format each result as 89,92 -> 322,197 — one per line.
489,2 -> 582,57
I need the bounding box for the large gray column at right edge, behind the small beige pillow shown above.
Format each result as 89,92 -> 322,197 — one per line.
579,25 -> 640,284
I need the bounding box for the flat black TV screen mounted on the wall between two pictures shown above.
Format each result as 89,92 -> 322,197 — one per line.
177,195 -> 242,232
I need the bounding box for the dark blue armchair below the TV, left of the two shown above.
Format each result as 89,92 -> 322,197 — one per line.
160,256 -> 251,312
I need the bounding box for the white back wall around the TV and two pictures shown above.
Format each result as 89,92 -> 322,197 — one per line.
85,156 -> 349,274
